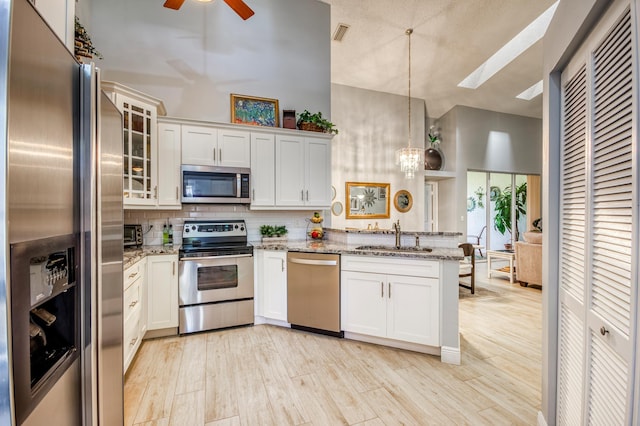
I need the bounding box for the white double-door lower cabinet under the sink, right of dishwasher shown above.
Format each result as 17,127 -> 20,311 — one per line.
341,256 -> 440,346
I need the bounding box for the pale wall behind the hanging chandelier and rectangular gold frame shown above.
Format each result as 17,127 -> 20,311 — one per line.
331,84 -> 425,231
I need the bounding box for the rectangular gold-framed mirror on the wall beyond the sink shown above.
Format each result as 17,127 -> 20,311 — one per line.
345,182 -> 390,219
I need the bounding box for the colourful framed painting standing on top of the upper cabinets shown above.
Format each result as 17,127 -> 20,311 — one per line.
231,93 -> 280,127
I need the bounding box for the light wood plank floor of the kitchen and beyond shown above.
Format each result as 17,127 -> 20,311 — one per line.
125,263 -> 542,426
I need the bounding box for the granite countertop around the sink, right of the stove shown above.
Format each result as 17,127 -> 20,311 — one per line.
251,240 -> 464,261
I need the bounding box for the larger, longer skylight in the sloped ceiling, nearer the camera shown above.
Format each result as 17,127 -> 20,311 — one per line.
458,1 -> 558,89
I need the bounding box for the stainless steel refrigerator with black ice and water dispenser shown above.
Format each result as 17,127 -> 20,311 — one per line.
0,0 -> 123,425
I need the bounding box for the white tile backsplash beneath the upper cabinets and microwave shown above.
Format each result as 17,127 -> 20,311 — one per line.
124,204 -> 328,245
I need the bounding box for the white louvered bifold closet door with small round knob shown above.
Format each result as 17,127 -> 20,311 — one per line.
558,2 -> 637,425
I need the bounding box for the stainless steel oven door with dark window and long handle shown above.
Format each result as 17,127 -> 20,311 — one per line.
179,254 -> 253,306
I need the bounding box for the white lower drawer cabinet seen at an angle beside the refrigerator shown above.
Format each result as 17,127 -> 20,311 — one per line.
122,258 -> 147,373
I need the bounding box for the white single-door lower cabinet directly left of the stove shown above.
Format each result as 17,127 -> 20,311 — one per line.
147,254 -> 178,331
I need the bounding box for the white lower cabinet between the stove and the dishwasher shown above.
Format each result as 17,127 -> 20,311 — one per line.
256,250 -> 287,323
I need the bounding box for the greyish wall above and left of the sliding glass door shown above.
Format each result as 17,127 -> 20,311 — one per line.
438,106 -> 542,235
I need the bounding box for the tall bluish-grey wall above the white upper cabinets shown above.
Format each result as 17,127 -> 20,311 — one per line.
87,0 -> 331,122
